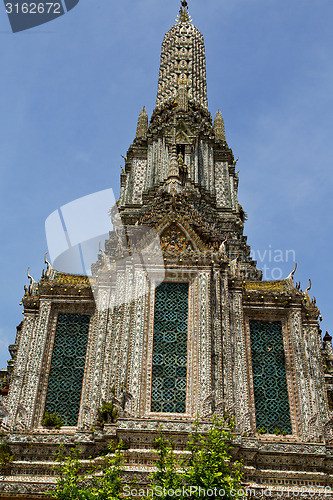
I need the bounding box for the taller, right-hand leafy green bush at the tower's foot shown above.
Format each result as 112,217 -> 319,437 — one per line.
151,419 -> 243,500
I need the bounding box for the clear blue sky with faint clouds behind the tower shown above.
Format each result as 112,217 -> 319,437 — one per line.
0,0 -> 333,367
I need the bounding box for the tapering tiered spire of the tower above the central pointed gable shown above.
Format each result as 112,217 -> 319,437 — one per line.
117,0 -> 261,280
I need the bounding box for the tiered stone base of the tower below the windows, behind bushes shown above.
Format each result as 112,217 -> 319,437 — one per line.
0,419 -> 333,500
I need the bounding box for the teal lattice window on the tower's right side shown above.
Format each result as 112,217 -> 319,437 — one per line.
250,320 -> 292,434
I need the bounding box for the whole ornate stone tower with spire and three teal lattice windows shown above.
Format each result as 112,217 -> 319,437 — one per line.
0,0 -> 333,498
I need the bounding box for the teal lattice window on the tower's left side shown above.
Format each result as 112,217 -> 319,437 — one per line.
45,313 -> 90,426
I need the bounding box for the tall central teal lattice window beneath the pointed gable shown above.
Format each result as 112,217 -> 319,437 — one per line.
151,283 -> 188,413
